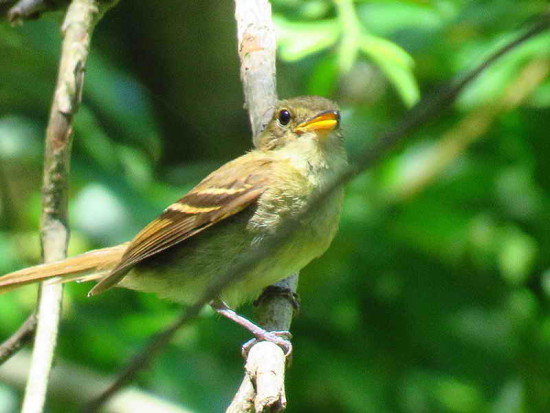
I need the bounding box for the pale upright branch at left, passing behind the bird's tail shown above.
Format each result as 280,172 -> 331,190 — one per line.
22,0 -> 117,413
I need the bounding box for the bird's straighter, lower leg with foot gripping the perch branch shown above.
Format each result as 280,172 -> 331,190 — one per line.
210,300 -> 292,356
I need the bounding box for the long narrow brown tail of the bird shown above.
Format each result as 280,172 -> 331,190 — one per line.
0,243 -> 128,294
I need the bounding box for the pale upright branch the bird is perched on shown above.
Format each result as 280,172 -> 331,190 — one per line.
231,0 -> 298,412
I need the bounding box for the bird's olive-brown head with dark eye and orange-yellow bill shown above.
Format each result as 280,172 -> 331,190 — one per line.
258,96 -> 342,150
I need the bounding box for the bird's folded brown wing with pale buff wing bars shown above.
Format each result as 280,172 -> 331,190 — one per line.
89,156 -> 272,295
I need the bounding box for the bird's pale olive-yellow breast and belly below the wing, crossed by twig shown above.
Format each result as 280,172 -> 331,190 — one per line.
122,159 -> 342,306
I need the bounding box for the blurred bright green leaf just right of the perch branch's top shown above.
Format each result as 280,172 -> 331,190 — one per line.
274,16 -> 340,62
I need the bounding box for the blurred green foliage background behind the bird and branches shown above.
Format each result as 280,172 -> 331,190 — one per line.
0,0 -> 550,413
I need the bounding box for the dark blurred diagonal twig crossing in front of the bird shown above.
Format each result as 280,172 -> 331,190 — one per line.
80,11 -> 550,406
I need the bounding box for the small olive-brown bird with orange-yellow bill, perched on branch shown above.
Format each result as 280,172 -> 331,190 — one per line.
0,96 -> 348,344
